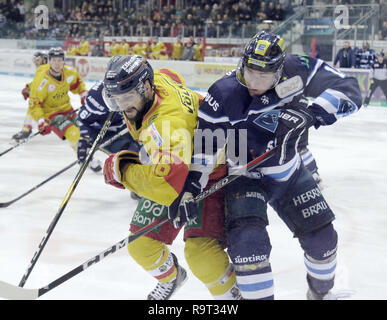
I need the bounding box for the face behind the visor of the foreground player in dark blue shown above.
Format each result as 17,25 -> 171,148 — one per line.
243,66 -> 276,96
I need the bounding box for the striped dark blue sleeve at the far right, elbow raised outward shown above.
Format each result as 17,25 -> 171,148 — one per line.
304,58 -> 362,126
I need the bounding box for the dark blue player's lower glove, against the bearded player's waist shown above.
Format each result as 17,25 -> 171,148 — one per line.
168,171 -> 201,229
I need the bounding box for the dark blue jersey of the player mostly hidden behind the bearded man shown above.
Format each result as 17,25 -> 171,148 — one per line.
78,81 -> 126,141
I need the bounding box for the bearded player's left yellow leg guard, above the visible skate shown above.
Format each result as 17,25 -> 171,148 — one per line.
128,236 -> 177,282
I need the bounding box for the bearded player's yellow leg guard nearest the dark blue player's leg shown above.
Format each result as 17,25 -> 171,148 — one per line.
184,237 -> 240,300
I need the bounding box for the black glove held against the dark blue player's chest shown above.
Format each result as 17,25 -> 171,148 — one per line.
275,105 -> 316,146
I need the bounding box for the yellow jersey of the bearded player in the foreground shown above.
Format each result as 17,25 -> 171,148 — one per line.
122,69 -> 202,205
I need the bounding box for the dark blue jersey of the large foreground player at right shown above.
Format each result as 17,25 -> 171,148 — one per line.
191,55 -> 362,187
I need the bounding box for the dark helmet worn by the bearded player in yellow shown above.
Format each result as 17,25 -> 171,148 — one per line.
103,55 -> 153,95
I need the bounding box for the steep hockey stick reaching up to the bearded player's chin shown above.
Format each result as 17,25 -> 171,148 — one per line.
19,111 -> 117,287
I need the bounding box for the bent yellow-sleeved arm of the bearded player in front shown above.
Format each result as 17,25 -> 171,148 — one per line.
122,118 -> 193,205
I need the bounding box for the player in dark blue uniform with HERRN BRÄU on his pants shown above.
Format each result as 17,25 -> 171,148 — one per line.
169,32 -> 362,299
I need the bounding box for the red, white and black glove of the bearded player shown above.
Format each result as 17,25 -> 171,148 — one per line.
103,150 -> 141,189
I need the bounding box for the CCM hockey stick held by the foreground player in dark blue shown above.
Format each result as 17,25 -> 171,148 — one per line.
0,147 -> 277,300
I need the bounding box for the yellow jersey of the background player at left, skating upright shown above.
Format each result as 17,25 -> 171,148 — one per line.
28,64 -> 87,121
